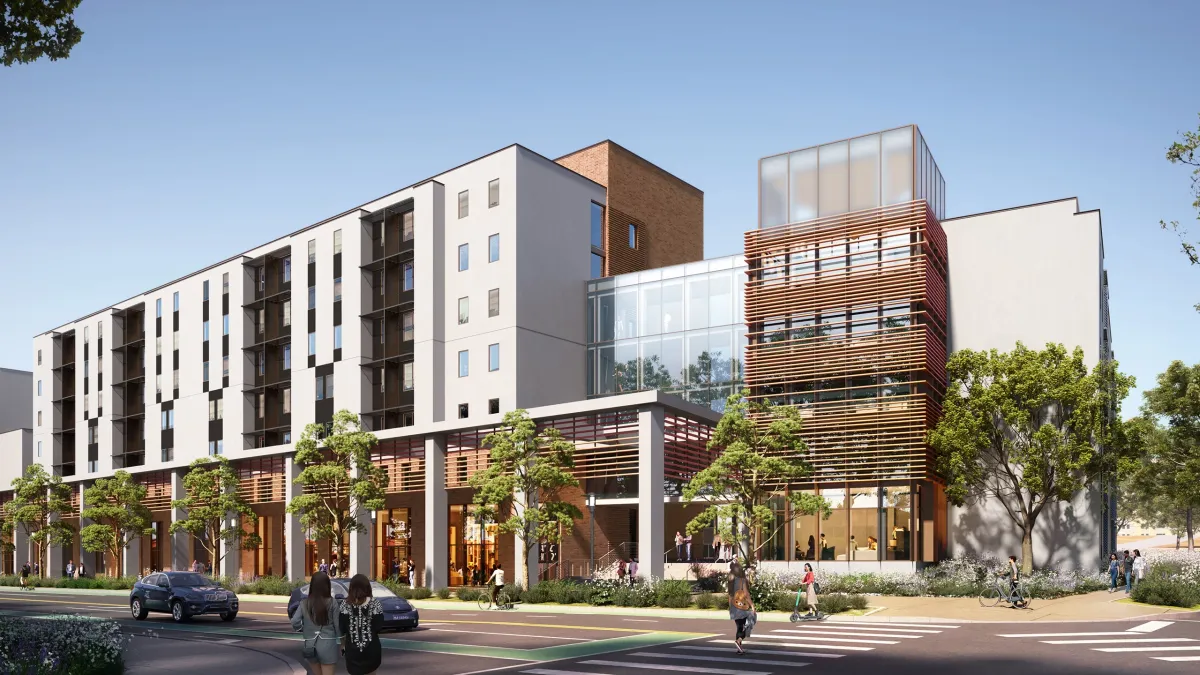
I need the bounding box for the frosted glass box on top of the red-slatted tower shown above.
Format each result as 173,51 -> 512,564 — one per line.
758,125 -> 946,227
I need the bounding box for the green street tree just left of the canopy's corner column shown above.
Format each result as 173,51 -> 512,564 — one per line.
469,410 -> 583,589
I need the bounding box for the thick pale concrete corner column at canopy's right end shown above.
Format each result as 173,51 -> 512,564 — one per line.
637,406 -> 665,579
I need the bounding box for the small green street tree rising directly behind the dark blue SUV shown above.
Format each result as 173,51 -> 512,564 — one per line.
168,455 -> 263,577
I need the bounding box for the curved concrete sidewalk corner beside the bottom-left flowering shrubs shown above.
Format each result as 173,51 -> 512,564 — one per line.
125,635 -> 307,675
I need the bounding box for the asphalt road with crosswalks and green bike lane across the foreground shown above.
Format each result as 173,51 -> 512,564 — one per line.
0,591 -> 1200,675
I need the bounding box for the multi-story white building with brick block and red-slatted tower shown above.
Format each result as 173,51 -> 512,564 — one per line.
9,126 -> 1110,586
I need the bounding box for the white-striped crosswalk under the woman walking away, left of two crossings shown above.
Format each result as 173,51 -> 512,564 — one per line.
521,621 -> 958,675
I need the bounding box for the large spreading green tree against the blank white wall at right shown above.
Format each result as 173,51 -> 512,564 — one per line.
929,342 -> 1134,566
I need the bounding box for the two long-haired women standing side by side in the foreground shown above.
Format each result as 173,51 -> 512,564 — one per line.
292,572 -> 383,675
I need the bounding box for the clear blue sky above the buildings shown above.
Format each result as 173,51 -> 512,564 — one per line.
0,0 -> 1200,414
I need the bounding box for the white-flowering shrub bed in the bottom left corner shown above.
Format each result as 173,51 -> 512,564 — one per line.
0,616 -> 128,675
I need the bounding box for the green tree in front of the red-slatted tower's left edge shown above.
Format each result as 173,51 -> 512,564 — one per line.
683,389 -> 832,563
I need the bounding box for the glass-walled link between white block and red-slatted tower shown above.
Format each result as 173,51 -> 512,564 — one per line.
587,256 -> 746,411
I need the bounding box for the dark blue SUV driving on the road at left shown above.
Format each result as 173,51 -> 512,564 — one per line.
130,572 -> 238,622
